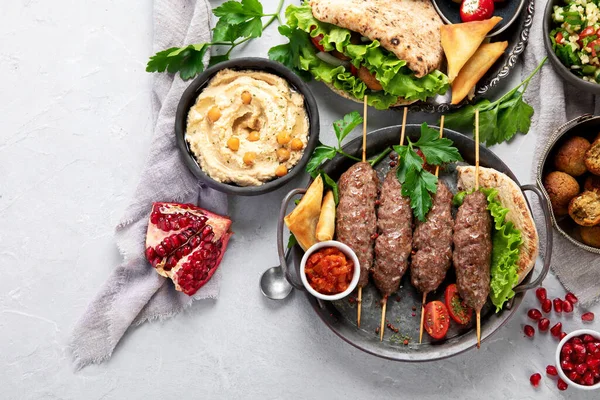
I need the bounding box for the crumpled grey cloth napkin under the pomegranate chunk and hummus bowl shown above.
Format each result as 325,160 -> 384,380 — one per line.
71,0 -> 227,369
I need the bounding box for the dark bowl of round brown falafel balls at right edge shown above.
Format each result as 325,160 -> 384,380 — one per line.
537,114 -> 600,254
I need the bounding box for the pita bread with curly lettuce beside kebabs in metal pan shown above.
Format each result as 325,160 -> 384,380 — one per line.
454,166 -> 539,311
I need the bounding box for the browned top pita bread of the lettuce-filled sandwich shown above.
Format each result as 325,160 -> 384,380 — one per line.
309,0 -> 444,78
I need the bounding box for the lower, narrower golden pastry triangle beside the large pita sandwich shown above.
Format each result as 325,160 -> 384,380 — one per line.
452,42 -> 508,104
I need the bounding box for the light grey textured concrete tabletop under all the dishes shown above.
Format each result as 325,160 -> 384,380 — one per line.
0,0 -> 600,399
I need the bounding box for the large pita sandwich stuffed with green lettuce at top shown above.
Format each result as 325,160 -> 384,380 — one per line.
269,0 -> 449,109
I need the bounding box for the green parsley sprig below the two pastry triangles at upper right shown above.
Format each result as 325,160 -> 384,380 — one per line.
445,57 -> 547,146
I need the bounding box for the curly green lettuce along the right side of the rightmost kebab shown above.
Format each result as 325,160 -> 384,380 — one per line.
453,188 -> 523,312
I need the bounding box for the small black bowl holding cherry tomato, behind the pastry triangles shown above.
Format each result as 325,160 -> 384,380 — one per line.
433,0 -> 526,37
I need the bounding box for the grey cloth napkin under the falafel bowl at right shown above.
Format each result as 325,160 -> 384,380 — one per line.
523,3 -> 600,305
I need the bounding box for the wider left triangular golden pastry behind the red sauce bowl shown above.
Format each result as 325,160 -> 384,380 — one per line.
284,175 -> 323,251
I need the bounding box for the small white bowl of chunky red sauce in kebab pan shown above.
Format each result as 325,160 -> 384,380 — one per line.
300,240 -> 360,301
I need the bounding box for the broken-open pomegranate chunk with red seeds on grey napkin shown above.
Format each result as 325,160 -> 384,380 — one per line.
146,203 -> 231,296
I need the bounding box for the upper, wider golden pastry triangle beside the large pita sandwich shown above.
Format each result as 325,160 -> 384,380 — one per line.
440,17 -> 502,83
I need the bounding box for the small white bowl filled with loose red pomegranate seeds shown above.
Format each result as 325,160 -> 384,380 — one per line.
556,329 -> 600,390
